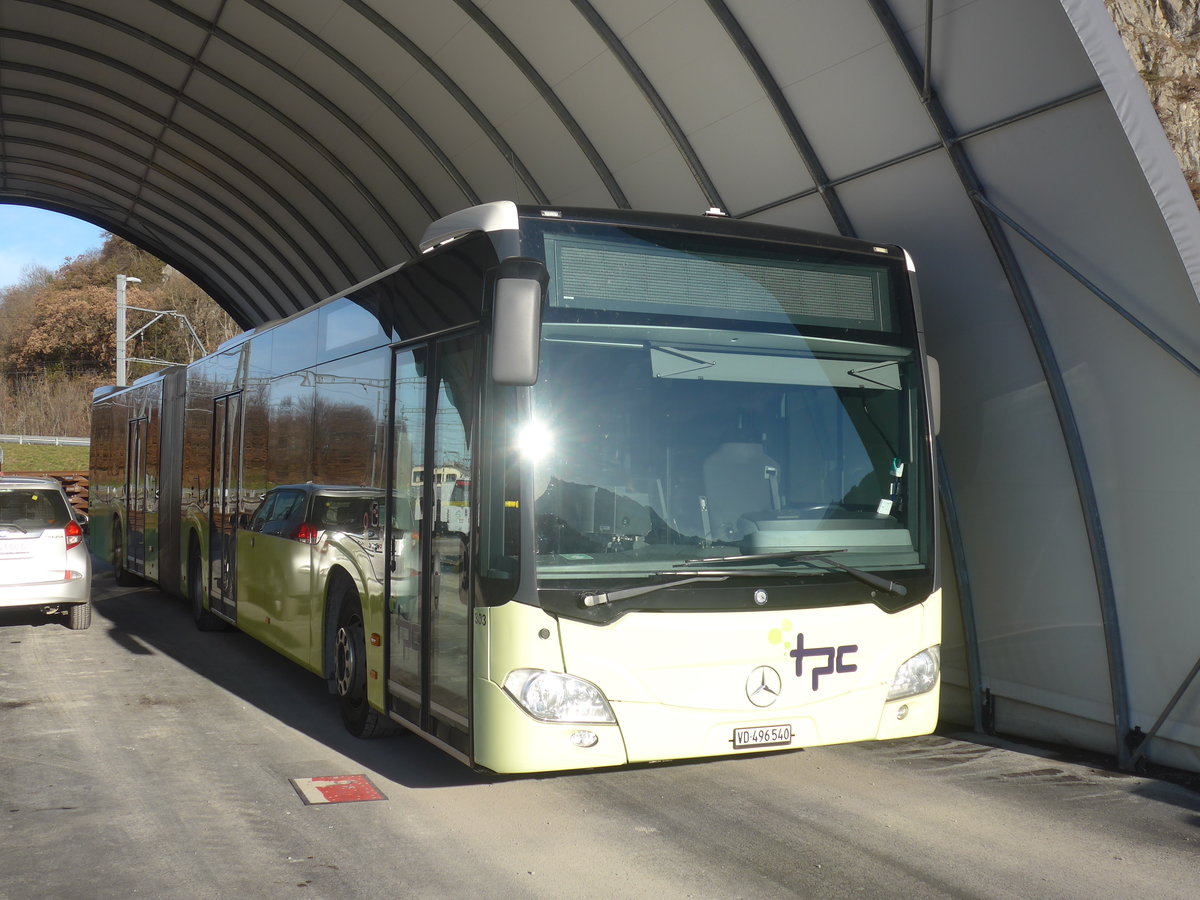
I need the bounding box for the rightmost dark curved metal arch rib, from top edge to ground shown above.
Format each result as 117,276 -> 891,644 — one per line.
866,0 -> 1130,768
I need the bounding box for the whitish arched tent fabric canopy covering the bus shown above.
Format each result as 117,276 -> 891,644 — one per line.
0,0 -> 1200,769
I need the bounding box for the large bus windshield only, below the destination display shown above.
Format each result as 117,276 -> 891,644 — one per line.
522,324 -> 928,580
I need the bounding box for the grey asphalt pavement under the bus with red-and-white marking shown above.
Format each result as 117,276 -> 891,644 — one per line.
0,572 -> 1200,900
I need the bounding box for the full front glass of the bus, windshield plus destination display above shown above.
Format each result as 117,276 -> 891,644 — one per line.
521,217 -> 931,588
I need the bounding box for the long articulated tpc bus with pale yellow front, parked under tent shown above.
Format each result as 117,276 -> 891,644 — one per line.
91,202 -> 941,773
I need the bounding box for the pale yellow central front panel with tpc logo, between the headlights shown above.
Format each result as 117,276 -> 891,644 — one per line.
562,593 -> 941,762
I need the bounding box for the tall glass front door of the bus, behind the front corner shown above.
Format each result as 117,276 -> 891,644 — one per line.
388,337 -> 478,760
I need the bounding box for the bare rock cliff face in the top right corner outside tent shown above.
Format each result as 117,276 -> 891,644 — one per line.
1104,0 -> 1200,203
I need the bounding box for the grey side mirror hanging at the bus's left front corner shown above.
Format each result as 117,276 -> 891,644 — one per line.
492,257 -> 550,386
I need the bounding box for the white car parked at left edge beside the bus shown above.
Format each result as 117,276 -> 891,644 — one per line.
0,475 -> 91,630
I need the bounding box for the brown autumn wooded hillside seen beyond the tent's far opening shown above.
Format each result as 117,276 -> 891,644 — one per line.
0,234 -> 240,437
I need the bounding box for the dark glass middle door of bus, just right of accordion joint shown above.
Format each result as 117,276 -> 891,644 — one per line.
209,391 -> 241,622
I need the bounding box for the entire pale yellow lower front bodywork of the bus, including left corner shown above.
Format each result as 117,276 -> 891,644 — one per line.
475,592 -> 942,772
